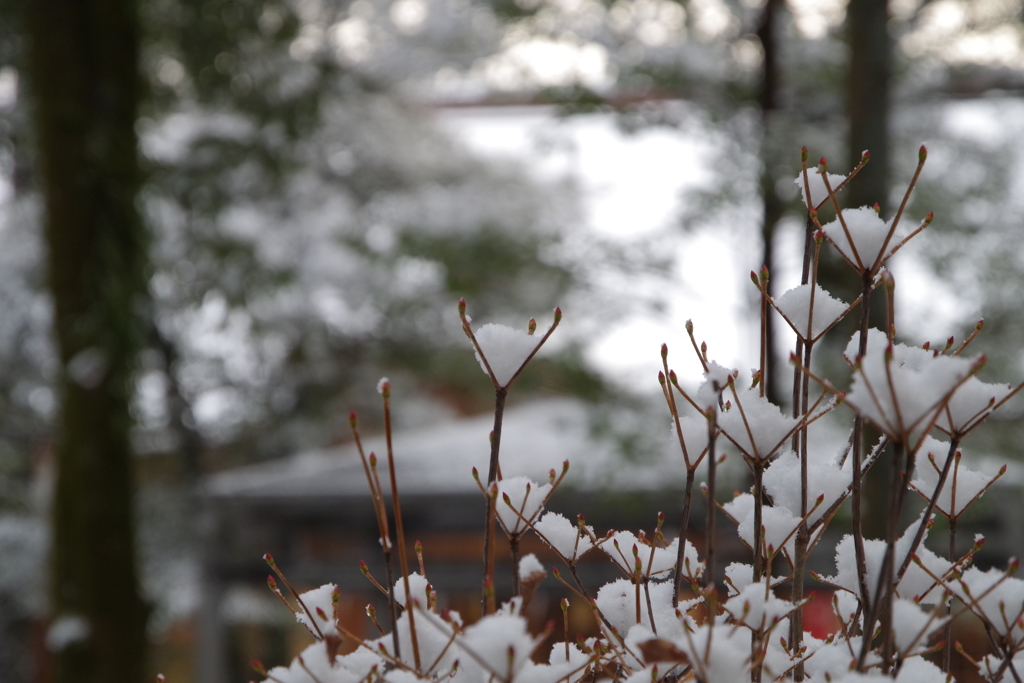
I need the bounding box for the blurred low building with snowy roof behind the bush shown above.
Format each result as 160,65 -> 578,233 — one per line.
196,399 -> 701,683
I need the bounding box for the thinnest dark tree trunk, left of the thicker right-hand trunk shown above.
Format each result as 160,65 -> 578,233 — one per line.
758,0 -> 785,404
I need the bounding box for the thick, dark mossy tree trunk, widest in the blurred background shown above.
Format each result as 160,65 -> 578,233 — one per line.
27,0 -> 146,683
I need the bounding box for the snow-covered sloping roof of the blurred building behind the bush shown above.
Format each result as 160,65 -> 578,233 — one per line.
206,398 -> 683,499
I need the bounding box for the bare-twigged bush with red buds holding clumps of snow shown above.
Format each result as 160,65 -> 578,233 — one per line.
245,147 -> 1024,683
